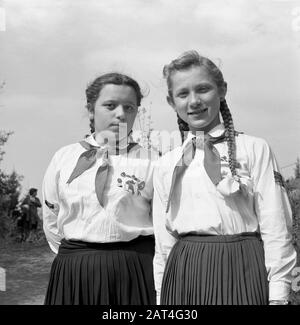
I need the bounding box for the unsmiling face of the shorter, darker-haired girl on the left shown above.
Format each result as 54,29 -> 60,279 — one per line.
89,84 -> 138,137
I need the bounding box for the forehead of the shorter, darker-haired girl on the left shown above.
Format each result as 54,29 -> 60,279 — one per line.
98,84 -> 137,103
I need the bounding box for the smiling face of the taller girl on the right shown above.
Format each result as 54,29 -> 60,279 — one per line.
167,66 -> 226,132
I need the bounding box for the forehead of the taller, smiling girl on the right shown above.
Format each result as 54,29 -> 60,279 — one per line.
171,66 -> 216,89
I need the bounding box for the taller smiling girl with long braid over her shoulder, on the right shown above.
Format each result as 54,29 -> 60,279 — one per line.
153,51 -> 296,305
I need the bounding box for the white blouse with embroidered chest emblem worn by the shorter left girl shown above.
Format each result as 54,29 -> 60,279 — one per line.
43,136 -> 155,253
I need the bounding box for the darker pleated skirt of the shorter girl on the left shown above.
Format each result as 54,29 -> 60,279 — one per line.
45,236 -> 155,305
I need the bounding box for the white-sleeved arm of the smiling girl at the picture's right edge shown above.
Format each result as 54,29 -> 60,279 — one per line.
252,139 -> 296,301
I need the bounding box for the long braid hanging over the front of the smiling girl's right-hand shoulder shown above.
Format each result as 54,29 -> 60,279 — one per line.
220,99 -> 237,176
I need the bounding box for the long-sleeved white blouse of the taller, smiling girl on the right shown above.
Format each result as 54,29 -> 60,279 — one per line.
153,124 -> 296,302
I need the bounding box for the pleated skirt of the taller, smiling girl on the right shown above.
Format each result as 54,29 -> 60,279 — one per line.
161,233 -> 268,305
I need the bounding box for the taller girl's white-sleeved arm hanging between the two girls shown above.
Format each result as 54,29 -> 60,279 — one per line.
153,168 -> 176,304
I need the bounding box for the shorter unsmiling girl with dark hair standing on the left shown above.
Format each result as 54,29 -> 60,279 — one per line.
43,73 -> 155,305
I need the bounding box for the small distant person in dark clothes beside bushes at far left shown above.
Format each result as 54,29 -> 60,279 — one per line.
21,188 -> 42,240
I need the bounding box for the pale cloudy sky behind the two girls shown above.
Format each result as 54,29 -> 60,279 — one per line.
0,0 -> 300,196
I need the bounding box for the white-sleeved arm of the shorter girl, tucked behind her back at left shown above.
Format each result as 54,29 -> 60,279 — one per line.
42,155 -> 61,254
